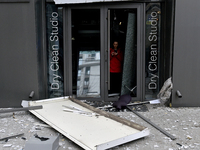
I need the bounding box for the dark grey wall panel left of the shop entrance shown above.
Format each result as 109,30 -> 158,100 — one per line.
0,0 -> 38,107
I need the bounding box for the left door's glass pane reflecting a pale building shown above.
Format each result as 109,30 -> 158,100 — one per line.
71,9 -> 101,97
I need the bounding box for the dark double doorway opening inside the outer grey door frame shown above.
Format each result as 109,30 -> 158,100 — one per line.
69,5 -> 141,101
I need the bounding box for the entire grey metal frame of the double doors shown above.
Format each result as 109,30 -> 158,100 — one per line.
63,2 -> 145,101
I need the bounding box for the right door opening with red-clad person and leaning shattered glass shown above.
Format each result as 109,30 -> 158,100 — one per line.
108,9 -> 137,97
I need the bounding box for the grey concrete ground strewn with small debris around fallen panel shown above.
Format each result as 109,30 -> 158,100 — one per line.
0,105 -> 200,150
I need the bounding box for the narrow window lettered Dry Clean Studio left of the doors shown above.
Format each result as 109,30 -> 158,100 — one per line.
46,3 -> 64,98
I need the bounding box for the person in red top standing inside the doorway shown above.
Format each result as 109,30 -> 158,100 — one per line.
109,41 -> 123,94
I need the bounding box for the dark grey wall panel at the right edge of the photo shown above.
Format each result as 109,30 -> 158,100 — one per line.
172,0 -> 200,106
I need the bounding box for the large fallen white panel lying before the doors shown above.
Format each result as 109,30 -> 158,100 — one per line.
26,97 -> 149,150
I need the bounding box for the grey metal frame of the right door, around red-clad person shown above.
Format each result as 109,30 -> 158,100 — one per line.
104,3 -> 145,101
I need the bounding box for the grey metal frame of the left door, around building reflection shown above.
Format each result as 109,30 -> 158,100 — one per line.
63,4 -> 105,101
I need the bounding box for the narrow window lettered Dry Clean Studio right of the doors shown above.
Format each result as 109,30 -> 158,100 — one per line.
145,3 -> 161,99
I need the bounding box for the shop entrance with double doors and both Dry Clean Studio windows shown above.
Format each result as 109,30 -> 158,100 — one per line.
39,2 -> 167,100
